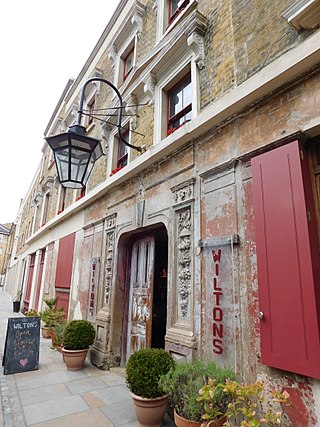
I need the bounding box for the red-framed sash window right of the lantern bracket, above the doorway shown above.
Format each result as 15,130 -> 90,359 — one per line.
167,73 -> 192,135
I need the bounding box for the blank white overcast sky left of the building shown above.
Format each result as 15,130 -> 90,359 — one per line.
0,0 -> 119,224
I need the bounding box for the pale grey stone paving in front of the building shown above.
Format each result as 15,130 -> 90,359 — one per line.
0,288 -> 175,427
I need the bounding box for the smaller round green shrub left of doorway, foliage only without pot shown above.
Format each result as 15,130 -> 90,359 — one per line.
62,320 -> 96,350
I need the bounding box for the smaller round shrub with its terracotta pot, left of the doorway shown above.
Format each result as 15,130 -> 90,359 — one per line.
62,320 -> 96,371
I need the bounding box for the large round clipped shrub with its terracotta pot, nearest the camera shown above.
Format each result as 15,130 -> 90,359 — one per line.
126,348 -> 174,427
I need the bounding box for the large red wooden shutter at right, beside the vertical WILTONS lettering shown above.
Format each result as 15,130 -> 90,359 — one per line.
252,141 -> 320,378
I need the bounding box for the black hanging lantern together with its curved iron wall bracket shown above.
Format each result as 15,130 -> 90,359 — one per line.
45,77 -> 141,189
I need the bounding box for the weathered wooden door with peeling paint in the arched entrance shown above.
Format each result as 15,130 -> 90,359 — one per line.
127,236 -> 155,360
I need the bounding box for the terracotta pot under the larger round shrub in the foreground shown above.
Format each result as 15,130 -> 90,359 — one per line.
130,392 -> 168,427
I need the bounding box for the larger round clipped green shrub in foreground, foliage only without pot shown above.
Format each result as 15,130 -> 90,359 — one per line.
126,348 -> 174,398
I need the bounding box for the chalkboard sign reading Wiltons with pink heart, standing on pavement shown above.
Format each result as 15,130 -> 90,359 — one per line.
2,317 -> 40,375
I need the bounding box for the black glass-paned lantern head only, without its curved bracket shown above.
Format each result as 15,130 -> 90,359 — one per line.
45,125 -> 103,189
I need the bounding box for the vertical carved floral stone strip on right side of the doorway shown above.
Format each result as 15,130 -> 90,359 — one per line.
177,207 -> 192,317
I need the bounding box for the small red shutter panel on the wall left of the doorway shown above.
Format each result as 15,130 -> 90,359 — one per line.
55,233 -> 75,289
